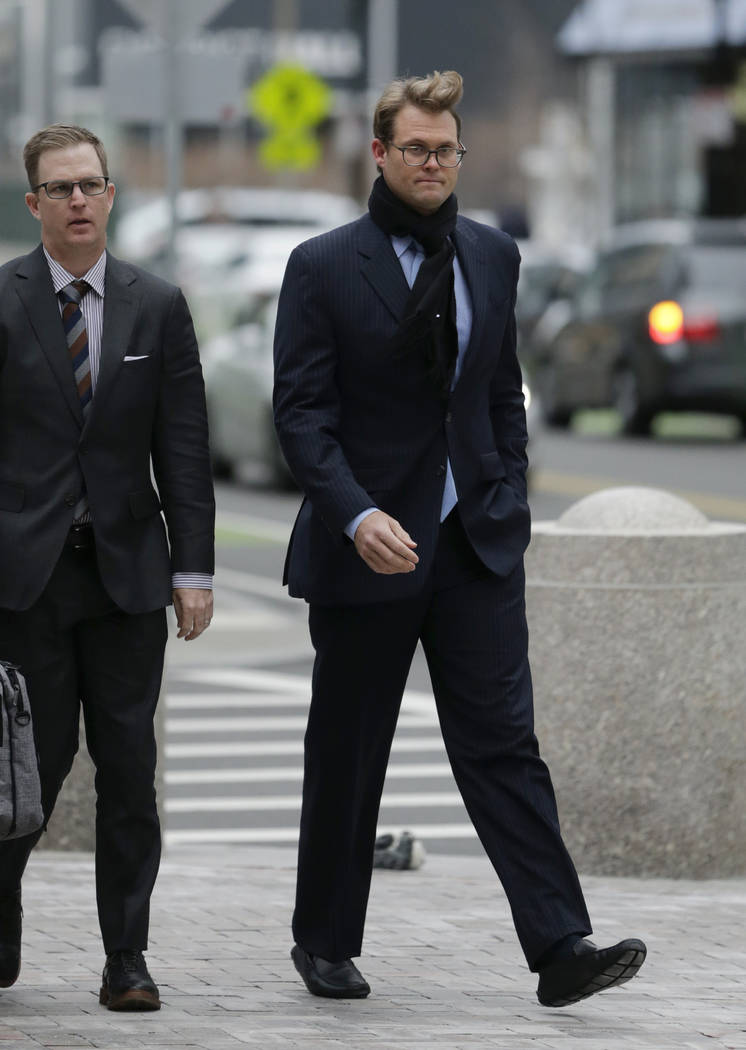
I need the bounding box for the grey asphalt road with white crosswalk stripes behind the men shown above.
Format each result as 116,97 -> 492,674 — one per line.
165,418 -> 746,854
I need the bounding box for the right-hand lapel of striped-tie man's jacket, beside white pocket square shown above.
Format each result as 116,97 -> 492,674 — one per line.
85,253 -> 140,428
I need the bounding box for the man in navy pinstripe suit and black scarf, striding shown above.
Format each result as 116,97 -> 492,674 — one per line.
274,71 -> 645,1006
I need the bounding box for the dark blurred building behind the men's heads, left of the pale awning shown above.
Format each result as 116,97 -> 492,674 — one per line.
0,0 -> 575,221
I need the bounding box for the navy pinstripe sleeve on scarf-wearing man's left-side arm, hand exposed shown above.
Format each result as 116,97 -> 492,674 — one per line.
273,246 -> 372,543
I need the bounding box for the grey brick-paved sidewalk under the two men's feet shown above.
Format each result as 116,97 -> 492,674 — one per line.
0,847 -> 746,1050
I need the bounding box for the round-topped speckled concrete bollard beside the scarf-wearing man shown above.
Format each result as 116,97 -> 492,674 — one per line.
525,488 -> 746,878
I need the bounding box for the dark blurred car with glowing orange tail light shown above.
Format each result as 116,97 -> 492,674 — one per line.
529,219 -> 746,435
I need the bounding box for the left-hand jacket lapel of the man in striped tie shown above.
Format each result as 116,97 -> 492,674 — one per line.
16,245 -> 83,426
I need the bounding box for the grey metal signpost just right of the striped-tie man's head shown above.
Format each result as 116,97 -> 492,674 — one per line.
163,0 -> 184,281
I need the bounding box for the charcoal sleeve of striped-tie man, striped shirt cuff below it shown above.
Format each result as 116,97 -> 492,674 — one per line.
152,289 -> 215,574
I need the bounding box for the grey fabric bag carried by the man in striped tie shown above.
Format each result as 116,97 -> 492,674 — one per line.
0,660 -> 44,841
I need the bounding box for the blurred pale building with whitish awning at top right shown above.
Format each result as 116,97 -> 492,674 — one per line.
558,0 -> 746,238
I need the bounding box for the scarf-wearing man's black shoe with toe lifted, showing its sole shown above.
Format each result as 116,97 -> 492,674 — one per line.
536,938 -> 647,1006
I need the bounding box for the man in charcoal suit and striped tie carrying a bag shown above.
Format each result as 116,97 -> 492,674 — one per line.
0,124 -> 214,1010
